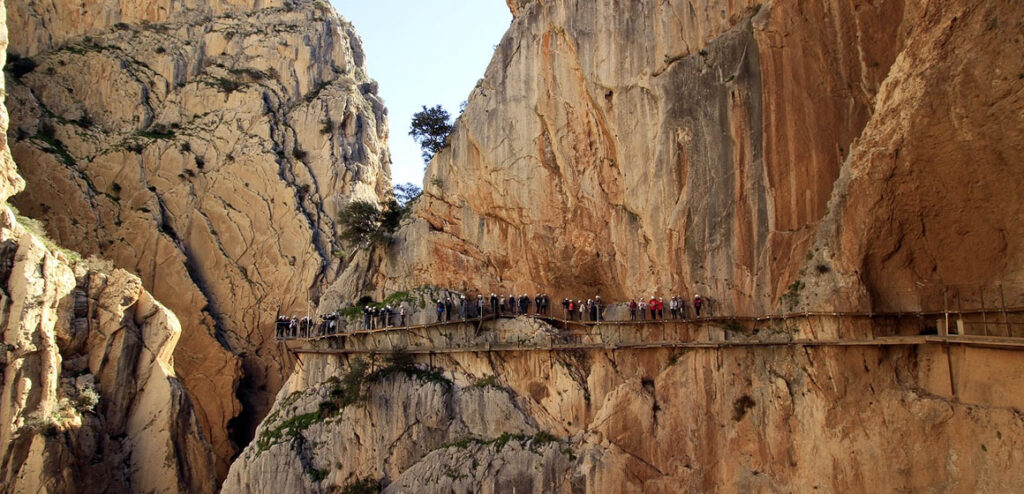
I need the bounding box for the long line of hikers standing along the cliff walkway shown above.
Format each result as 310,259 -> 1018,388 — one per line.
275,293 -> 708,339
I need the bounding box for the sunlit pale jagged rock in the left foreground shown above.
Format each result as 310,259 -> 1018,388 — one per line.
0,6 -> 217,493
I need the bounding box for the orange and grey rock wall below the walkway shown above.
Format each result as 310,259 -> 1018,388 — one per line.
223,321 -> 1024,493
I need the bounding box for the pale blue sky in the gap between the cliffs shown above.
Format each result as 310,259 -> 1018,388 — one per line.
332,0 -> 512,186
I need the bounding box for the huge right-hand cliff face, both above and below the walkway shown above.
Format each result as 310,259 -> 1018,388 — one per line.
235,0 -> 1024,492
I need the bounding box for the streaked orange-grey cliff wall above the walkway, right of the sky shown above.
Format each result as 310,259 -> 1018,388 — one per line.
362,0 -> 1024,314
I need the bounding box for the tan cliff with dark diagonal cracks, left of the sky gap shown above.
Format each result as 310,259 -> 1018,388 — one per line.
7,0 -> 390,476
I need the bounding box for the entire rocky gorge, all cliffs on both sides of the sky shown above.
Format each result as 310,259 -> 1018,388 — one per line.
0,0 -> 1024,493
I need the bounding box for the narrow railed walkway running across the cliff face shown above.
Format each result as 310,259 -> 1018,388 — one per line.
275,282 -> 1024,346
